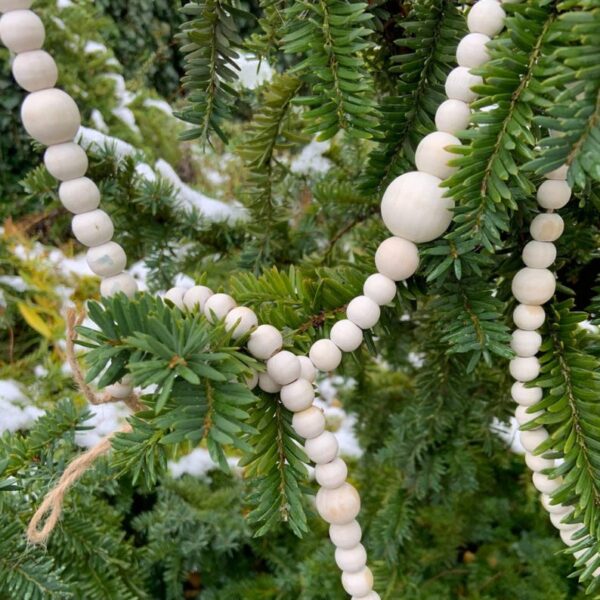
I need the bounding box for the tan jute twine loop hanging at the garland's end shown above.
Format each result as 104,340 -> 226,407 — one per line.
27,309 -> 142,544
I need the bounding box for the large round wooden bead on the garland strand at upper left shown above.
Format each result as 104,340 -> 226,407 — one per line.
21,88 -> 81,146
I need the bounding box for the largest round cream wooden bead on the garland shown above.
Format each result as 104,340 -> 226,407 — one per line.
381,171 -> 454,244
